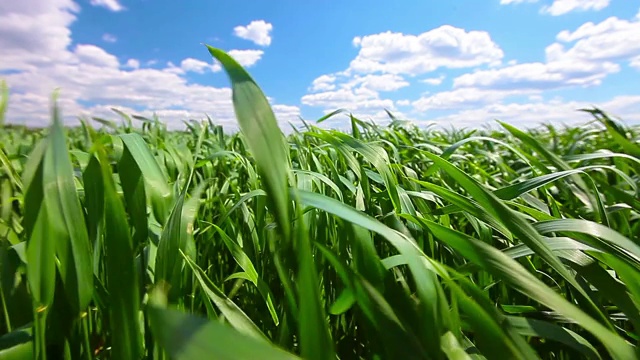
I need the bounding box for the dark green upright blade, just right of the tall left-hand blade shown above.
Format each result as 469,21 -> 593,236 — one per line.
95,150 -> 142,359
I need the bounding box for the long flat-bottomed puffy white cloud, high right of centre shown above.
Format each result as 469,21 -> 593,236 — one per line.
349,25 -> 504,75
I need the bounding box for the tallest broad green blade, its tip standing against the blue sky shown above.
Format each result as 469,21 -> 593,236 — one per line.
207,45 -> 291,242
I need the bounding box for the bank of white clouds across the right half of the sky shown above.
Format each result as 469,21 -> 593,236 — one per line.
302,10 -> 640,124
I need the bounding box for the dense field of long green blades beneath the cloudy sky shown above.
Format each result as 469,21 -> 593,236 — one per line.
0,48 -> 640,360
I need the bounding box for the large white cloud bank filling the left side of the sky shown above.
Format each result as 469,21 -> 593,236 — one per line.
0,0 -> 299,128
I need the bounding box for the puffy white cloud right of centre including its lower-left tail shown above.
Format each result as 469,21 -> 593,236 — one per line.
301,25 -> 503,117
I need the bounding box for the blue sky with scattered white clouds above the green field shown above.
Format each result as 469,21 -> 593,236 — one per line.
0,0 -> 640,129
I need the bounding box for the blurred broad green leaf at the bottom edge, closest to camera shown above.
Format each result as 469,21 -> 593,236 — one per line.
148,291 -> 299,360
